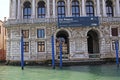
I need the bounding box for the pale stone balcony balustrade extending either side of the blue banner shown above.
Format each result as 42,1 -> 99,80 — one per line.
5,17 -> 120,26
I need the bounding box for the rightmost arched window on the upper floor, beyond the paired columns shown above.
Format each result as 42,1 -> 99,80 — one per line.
106,0 -> 113,17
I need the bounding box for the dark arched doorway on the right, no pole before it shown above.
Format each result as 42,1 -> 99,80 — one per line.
87,30 -> 99,58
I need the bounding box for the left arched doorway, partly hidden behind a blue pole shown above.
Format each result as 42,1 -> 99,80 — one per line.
56,30 -> 69,59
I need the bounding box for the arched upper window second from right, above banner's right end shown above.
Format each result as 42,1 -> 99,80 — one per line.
86,0 -> 94,16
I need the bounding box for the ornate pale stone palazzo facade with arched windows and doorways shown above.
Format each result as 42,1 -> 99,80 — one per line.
5,0 -> 120,61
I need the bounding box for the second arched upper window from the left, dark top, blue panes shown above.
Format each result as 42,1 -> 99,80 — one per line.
38,1 -> 45,18
